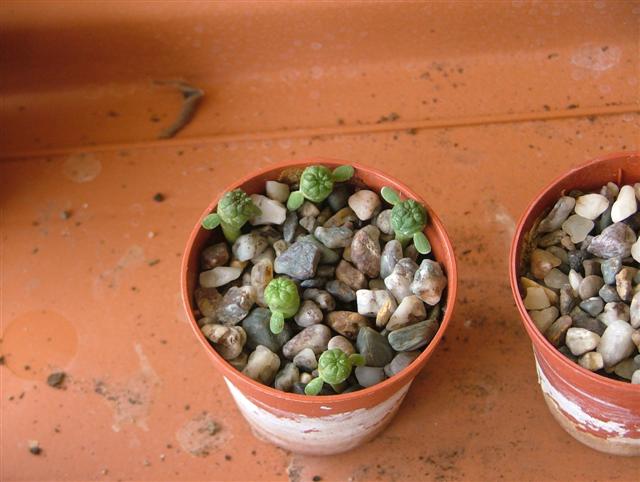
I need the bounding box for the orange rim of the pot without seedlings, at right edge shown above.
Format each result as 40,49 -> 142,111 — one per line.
509,151 -> 640,393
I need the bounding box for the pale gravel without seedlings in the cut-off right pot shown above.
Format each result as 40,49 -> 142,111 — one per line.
520,183 -> 640,384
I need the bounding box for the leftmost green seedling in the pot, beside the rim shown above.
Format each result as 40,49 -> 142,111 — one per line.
202,189 -> 261,243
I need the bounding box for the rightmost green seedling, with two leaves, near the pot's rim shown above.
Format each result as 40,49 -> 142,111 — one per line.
380,186 -> 431,254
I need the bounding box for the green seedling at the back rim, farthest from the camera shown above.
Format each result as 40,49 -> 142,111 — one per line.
287,165 -> 354,211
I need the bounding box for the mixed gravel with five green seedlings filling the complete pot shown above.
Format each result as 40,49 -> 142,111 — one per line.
194,166 -> 447,395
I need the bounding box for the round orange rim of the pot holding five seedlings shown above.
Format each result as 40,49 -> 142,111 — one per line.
180,157 -> 458,405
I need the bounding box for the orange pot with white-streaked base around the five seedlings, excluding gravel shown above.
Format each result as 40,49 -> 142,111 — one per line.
181,159 -> 457,455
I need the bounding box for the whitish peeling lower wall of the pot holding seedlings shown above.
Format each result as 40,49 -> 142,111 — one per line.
225,378 -> 411,455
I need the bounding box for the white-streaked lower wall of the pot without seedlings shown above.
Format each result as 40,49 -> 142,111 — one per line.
536,359 -> 640,456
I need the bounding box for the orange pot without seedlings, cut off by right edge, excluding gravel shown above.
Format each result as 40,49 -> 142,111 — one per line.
509,153 -> 640,455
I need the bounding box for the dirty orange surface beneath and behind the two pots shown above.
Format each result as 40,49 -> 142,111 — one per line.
0,1 -> 640,481
